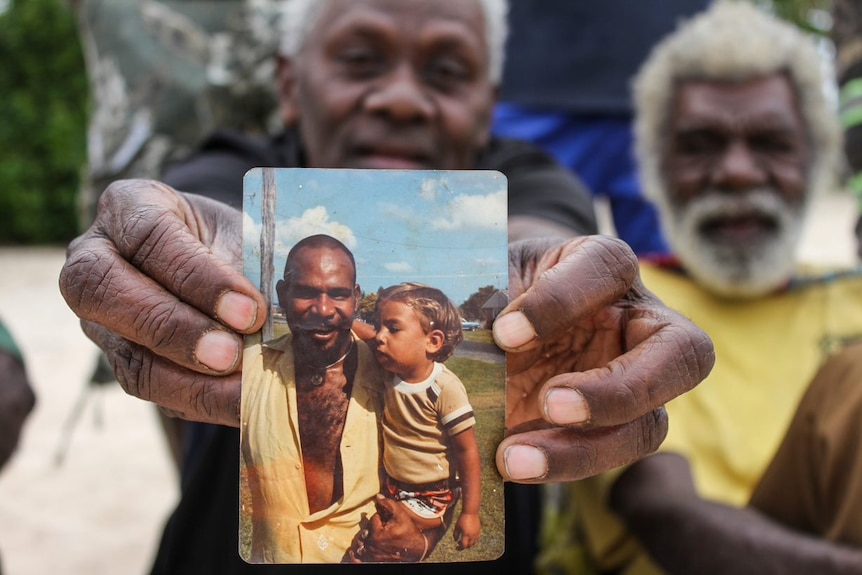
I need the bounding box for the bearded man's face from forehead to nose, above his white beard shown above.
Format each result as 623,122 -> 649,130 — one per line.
662,74 -> 811,212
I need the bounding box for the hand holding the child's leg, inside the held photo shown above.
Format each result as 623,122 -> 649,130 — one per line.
344,495 -> 432,563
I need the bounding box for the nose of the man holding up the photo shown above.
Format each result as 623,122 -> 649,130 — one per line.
366,63 -> 434,122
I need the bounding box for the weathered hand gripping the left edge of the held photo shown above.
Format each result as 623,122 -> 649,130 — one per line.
60,180 -> 266,426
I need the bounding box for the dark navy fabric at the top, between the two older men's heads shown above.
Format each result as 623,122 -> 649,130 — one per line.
500,0 -> 710,115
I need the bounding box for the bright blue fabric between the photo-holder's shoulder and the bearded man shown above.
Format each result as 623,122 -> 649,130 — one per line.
493,103 -> 669,255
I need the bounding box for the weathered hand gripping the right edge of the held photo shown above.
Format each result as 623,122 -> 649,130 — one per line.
494,236 -> 715,483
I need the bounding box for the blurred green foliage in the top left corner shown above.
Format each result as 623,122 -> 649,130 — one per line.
0,0 -> 87,244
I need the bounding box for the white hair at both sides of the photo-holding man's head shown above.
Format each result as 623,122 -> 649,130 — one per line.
279,0 -> 508,85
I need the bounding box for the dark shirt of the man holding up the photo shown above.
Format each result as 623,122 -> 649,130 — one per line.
152,131 -> 596,575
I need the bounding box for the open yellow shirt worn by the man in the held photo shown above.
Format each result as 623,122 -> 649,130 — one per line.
240,334 -> 383,563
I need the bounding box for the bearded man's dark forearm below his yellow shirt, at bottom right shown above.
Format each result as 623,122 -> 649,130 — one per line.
611,453 -> 862,575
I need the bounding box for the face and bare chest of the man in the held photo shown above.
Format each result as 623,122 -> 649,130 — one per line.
276,246 -> 360,513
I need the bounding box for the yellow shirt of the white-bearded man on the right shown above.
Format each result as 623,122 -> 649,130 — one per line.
556,263 -> 862,574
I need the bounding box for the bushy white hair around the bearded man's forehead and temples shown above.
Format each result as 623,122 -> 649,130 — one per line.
633,0 -> 842,213
